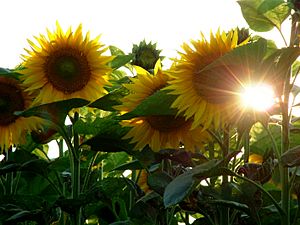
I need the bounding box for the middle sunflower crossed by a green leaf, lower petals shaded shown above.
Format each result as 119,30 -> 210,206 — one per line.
117,60 -> 209,151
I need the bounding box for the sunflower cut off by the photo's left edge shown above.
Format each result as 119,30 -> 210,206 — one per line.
0,76 -> 43,150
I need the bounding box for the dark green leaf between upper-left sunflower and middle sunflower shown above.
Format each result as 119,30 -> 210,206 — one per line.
89,87 -> 128,111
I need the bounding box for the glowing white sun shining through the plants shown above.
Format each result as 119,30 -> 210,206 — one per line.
241,84 -> 275,111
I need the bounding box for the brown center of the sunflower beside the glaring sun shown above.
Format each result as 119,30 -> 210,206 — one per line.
193,67 -> 241,104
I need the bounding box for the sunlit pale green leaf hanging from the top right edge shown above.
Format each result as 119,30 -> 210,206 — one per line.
238,0 -> 290,32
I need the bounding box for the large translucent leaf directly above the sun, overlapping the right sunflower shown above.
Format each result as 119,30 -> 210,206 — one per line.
200,38 -> 300,90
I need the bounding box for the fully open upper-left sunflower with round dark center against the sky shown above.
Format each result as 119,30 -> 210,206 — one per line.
22,23 -> 113,103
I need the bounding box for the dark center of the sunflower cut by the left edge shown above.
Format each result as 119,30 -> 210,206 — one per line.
0,83 -> 25,126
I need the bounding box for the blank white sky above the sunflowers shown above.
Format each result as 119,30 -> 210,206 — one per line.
0,0 -> 290,68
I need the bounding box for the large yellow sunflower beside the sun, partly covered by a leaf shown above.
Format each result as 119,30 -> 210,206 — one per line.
166,30 -> 248,129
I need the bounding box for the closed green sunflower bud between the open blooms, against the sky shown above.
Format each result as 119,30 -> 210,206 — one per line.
132,40 -> 164,71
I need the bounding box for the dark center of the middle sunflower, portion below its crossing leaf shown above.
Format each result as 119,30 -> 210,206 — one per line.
145,116 -> 187,132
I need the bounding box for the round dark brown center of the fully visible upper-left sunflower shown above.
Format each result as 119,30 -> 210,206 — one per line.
45,48 -> 91,94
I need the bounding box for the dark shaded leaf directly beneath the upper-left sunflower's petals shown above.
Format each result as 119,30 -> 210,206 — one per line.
15,98 -> 89,125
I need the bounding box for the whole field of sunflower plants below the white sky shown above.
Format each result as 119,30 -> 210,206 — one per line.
0,0 -> 300,225
